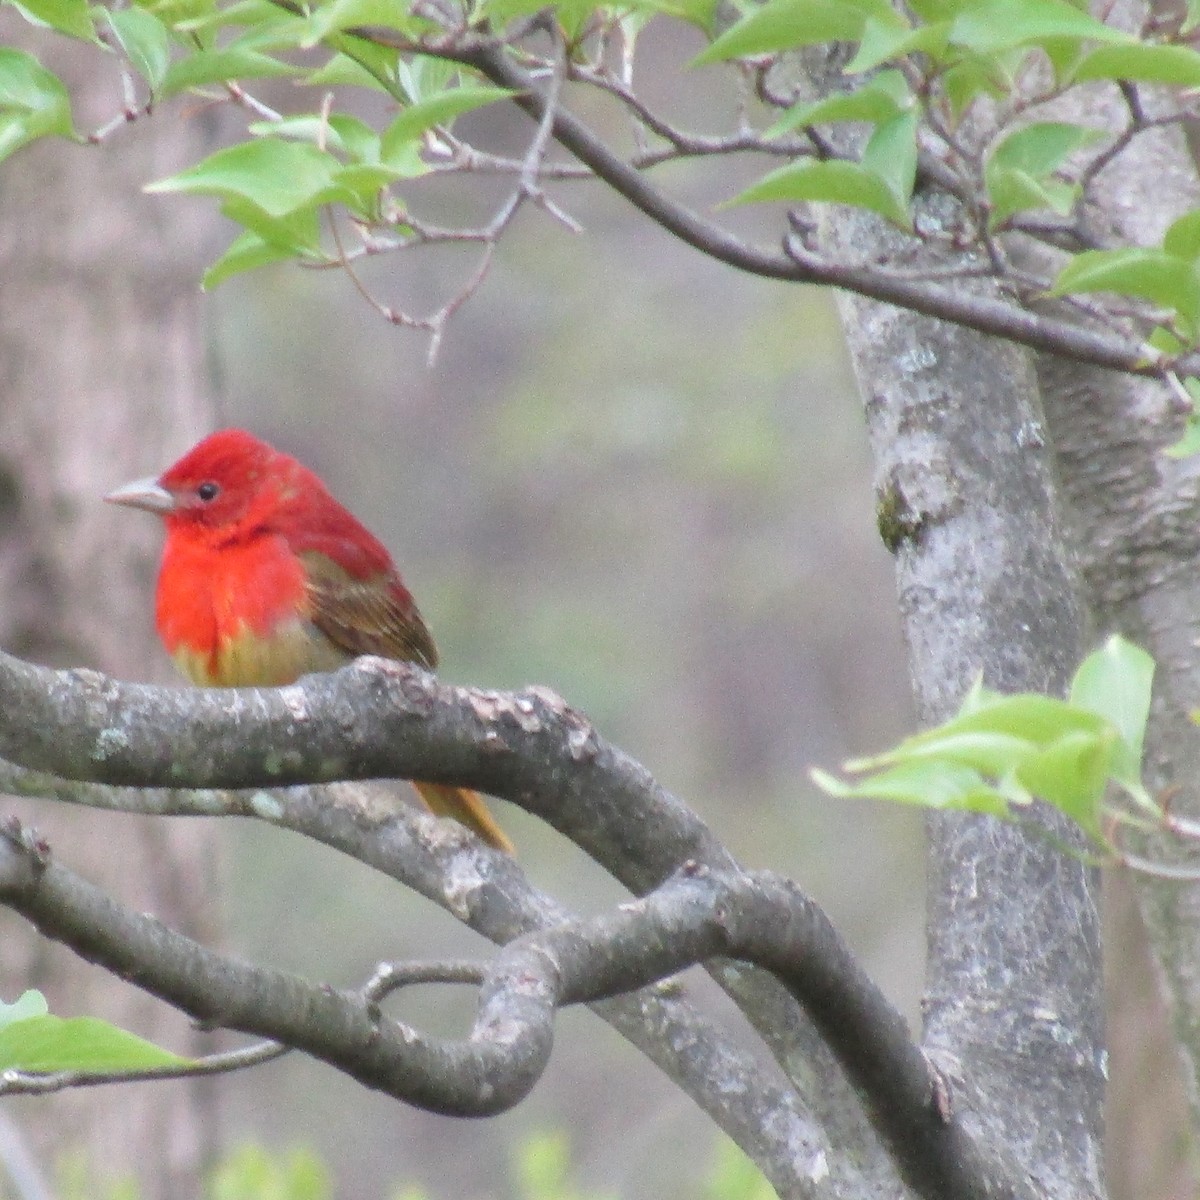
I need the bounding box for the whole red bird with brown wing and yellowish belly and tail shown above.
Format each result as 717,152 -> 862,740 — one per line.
104,430 -> 512,853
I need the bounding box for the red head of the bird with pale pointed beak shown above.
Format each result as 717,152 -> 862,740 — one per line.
104,430 -> 285,530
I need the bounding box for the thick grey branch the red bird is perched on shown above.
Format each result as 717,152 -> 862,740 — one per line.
0,654 -> 728,873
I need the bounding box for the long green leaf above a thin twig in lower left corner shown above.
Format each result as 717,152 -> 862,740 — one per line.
0,1015 -> 192,1073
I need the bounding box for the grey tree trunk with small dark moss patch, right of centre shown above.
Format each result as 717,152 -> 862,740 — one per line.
834,216 -> 1104,1196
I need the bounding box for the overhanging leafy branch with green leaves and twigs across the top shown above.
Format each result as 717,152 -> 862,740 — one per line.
7,0 -> 1200,374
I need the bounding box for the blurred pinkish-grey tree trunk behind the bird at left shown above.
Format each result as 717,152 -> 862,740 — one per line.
0,21 -> 218,1198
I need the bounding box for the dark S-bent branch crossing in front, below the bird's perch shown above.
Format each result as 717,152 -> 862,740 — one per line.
0,826 -> 1033,1198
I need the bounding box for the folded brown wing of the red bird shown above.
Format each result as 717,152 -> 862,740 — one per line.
300,551 -> 438,670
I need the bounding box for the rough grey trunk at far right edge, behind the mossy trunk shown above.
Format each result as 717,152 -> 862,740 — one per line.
1031,89 -> 1200,1194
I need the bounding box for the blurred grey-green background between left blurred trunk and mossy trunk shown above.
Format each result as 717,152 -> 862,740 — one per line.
199,98 -> 923,1200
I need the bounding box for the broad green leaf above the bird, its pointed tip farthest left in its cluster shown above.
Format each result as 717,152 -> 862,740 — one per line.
145,138 -> 341,217
